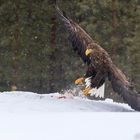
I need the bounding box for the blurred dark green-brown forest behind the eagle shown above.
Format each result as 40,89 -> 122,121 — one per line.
0,0 -> 140,98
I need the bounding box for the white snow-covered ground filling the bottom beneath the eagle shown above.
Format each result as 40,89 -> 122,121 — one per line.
0,92 -> 140,140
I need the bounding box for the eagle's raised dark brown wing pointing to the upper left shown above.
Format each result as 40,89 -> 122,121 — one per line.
56,6 -> 93,64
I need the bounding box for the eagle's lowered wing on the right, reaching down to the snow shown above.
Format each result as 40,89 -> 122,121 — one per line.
109,65 -> 140,111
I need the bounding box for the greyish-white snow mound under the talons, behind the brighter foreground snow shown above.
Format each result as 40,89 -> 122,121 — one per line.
0,91 -> 133,113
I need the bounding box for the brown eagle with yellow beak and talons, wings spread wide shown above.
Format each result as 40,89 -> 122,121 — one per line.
56,6 -> 140,111
